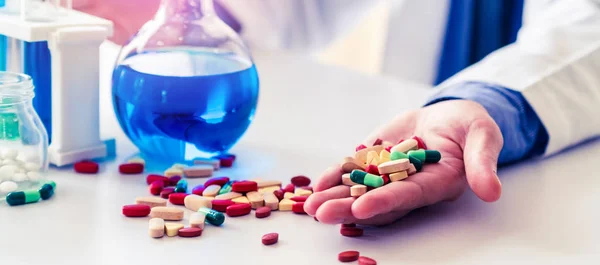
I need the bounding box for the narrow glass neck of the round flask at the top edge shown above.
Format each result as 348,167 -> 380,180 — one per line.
155,0 -> 215,21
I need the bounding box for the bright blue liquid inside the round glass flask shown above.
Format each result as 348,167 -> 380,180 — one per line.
113,50 -> 259,162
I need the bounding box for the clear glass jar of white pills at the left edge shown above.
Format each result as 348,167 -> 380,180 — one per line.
0,72 -> 48,198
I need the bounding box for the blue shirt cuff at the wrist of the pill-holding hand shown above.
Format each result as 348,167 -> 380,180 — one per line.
425,82 -> 549,165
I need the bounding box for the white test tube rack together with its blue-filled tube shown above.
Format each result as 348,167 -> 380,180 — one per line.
0,8 -> 114,167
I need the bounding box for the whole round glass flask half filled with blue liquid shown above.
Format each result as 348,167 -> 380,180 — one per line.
112,0 -> 259,162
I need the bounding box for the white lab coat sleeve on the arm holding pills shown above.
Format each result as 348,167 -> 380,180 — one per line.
439,0 -> 600,156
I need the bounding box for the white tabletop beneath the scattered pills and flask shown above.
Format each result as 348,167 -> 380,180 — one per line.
0,44 -> 600,265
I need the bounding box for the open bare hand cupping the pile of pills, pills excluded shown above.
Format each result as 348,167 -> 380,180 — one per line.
305,100 -> 503,225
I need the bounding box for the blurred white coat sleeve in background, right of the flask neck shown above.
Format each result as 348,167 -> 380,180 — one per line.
219,0 -> 382,52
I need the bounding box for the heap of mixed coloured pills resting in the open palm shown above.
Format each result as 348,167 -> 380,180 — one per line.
341,136 -> 441,197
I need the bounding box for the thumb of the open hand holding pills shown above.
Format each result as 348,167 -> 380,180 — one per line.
463,118 -> 504,202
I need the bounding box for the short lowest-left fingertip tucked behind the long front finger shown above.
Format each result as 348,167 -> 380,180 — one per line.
311,196 -> 355,224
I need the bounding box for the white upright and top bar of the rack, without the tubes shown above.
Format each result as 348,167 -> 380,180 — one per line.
0,9 -> 113,166
